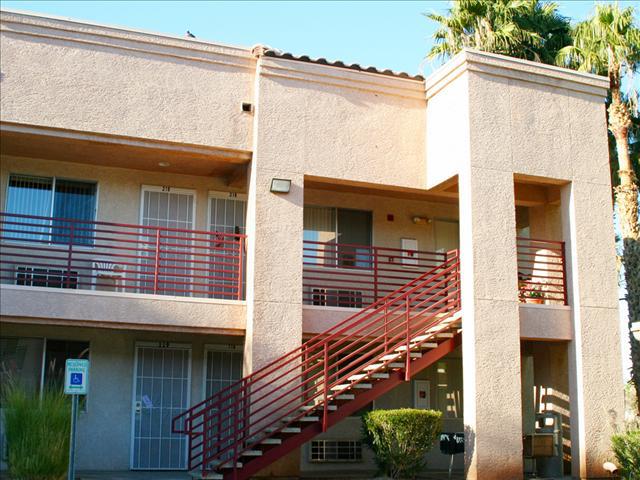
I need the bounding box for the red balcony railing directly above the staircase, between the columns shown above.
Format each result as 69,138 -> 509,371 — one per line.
302,240 -> 447,308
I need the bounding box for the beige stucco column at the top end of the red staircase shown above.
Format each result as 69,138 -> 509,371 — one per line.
459,165 -> 523,480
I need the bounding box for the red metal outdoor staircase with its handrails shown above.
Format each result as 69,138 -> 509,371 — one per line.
173,251 -> 461,480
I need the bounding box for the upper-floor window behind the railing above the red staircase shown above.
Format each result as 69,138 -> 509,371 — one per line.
304,206 -> 373,268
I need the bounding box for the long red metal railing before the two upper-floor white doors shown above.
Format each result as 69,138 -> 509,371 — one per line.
0,213 -> 245,300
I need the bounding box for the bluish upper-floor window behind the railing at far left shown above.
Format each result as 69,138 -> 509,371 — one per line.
6,175 -> 97,245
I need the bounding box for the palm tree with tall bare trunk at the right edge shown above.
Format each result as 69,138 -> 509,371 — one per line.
557,4 -> 640,413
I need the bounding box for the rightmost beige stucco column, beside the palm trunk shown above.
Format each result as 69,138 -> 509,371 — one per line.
561,181 -> 624,479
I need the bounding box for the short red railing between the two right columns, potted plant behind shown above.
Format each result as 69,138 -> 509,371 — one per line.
516,237 -> 568,305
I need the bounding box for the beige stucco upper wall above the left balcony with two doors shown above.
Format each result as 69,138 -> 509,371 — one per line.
0,12 -> 255,150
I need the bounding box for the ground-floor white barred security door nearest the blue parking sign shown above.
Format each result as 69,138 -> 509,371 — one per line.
131,342 -> 191,470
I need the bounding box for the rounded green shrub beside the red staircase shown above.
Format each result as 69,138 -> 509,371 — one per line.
362,408 -> 442,478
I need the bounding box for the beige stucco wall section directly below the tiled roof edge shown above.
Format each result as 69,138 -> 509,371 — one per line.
257,57 -> 426,188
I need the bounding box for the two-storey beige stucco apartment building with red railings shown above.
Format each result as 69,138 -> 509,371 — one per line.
0,11 -> 623,480
